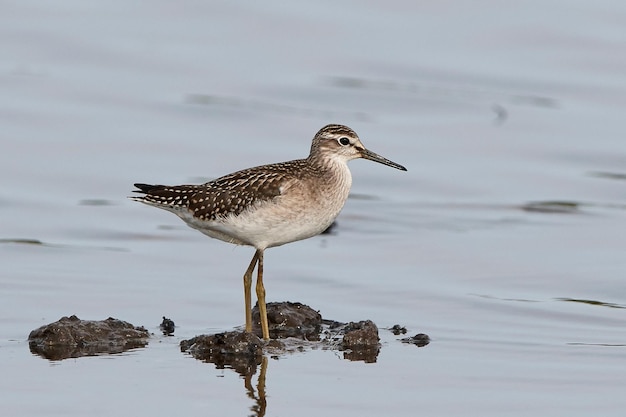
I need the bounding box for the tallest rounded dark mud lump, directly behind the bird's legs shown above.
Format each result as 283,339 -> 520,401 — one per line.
252,301 -> 322,340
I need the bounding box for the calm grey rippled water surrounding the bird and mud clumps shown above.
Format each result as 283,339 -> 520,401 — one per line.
0,1 -> 626,416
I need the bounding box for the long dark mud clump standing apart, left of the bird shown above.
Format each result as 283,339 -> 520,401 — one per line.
28,316 -> 150,360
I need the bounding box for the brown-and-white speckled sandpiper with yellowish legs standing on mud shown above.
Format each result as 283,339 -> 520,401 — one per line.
130,124 -> 406,340
